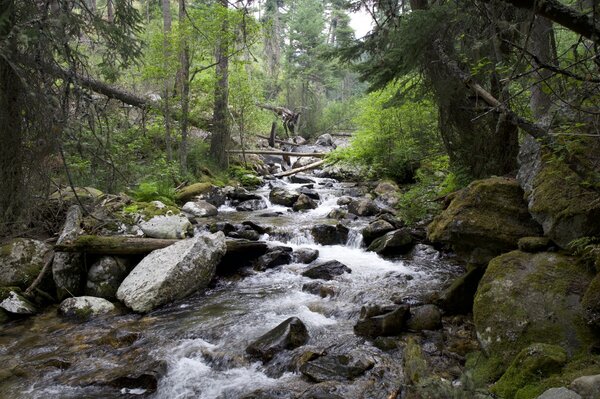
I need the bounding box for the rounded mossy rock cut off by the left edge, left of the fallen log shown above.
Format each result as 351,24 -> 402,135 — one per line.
0,238 -> 52,289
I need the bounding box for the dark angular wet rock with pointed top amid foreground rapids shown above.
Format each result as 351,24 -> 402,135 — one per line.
246,317 -> 309,362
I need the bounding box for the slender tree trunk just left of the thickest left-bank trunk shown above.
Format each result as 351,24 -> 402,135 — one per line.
179,0 -> 190,175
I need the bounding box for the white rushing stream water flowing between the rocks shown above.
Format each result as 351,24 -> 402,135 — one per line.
0,179 -> 459,399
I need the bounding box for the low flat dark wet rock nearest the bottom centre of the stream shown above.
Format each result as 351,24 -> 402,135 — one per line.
300,351 -> 375,382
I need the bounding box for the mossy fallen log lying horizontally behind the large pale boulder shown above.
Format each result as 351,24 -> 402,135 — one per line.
54,235 -> 267,255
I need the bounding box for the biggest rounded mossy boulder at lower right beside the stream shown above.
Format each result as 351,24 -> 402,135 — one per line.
473,251 -> 594,374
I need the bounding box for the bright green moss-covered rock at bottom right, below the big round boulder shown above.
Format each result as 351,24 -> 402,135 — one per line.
492,343 -> 567,399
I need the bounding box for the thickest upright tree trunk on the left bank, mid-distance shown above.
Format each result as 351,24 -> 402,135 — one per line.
210,0 -> 230,168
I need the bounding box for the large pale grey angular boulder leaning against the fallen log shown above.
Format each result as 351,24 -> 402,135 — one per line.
117,232 -> 227,313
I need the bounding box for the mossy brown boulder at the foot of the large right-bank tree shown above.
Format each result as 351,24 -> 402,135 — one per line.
428,177 -> 541,264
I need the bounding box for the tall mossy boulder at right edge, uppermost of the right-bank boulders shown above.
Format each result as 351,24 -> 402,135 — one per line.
517,138 -> 600,248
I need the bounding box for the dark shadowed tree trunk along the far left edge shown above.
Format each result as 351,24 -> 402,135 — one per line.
0,0 -> 24,236
